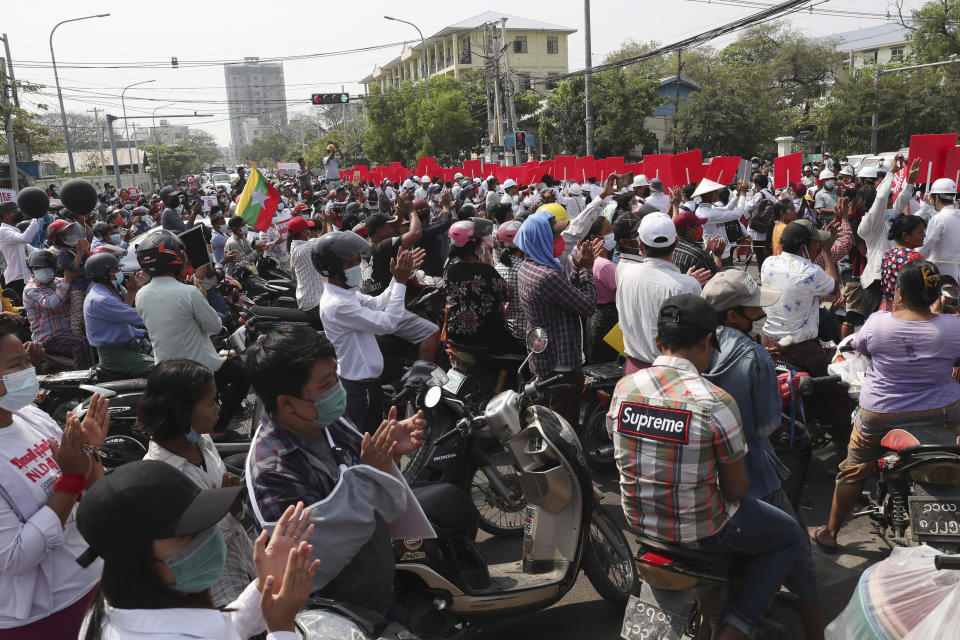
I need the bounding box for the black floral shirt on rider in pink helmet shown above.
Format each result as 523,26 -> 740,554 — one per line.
446,262 -> 510,346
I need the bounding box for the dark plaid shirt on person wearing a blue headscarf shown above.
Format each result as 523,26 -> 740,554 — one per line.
517,260 -> 597,375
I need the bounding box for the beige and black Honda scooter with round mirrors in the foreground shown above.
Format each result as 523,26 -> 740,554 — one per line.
394,329 -> 639,637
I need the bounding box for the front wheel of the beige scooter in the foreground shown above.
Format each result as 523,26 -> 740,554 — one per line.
583,505 -> 640,609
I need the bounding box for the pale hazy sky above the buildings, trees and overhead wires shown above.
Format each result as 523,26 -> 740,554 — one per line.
0,0 -> 922,144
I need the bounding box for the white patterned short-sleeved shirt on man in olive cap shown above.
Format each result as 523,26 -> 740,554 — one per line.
760,252 -> 836,346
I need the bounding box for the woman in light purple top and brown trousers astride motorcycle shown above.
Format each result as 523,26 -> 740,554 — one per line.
811,260 -> 960,553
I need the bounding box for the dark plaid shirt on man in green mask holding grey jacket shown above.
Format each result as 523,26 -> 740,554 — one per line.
243,413 -> 360,522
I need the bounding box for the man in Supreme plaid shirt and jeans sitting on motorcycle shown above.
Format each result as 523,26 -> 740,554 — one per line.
607,294 -> 803,640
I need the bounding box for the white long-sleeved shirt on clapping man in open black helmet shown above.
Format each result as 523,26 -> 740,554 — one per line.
320,280 -> 407,381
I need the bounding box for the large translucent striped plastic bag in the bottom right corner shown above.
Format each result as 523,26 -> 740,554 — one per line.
824,545 -> 960,640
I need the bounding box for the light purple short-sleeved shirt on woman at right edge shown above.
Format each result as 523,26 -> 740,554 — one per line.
853,311 -> 960,413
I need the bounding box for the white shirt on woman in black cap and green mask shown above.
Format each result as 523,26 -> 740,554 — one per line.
86,583 -> 297,640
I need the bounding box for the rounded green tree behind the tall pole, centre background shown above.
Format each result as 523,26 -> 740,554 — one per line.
540,69 -> 662,157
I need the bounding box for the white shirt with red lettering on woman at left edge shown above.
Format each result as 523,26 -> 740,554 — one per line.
0,405 -> 103,629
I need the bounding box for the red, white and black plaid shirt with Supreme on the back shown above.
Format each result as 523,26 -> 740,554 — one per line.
607,356 -> 747,544
